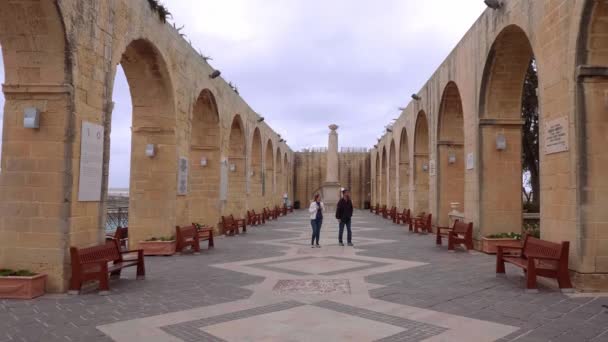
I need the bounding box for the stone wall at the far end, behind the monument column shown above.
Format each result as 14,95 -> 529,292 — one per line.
294,152 -> 371,208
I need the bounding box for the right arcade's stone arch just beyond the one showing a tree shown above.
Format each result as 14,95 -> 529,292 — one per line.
437,82 -> 465,226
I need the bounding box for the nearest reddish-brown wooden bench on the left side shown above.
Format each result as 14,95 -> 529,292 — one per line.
69,241 -> 146,295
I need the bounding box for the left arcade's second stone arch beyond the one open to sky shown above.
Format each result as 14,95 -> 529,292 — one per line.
226,114 -> 247,217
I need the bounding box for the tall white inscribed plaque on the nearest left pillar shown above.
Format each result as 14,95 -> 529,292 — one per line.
78,121 -> 104,202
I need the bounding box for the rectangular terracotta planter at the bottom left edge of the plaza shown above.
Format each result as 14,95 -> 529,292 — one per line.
0,269 -> 46,299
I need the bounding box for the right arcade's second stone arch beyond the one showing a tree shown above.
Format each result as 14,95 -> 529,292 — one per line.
414,110 -> 430,213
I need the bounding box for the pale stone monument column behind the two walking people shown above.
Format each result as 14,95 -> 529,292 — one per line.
323,125 -> 340,213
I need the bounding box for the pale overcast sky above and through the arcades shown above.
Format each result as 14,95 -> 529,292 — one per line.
0,0 -> 485,187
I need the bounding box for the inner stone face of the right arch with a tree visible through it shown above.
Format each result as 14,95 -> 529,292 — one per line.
479,25 -> 542,235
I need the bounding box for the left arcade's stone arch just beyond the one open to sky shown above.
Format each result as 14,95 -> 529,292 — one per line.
188,89 -> 221,226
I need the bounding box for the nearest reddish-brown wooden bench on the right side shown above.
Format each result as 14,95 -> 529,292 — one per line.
496,235 -> 574,292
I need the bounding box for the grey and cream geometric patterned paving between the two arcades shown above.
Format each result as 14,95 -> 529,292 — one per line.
0,211 -> 608,342
